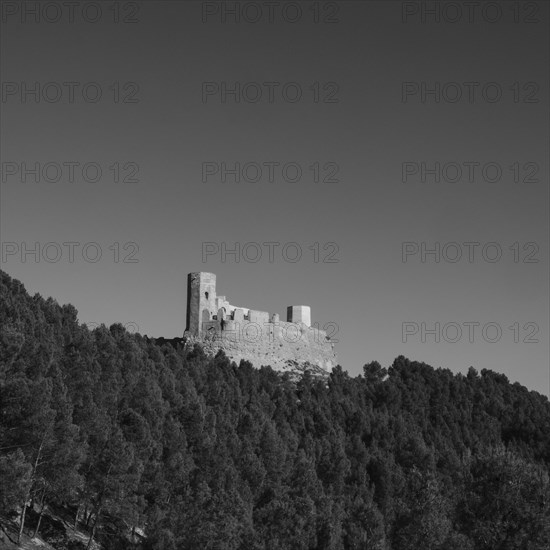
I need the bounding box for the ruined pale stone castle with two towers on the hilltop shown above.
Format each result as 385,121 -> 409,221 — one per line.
184,272 -> 337,372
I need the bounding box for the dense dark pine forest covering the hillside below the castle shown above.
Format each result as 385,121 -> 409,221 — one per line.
0,272 -> 550,550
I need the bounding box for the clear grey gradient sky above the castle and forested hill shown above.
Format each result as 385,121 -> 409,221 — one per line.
0,0 -> 550,394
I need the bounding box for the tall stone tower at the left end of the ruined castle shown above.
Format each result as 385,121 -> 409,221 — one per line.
185,271 -> 217,336
